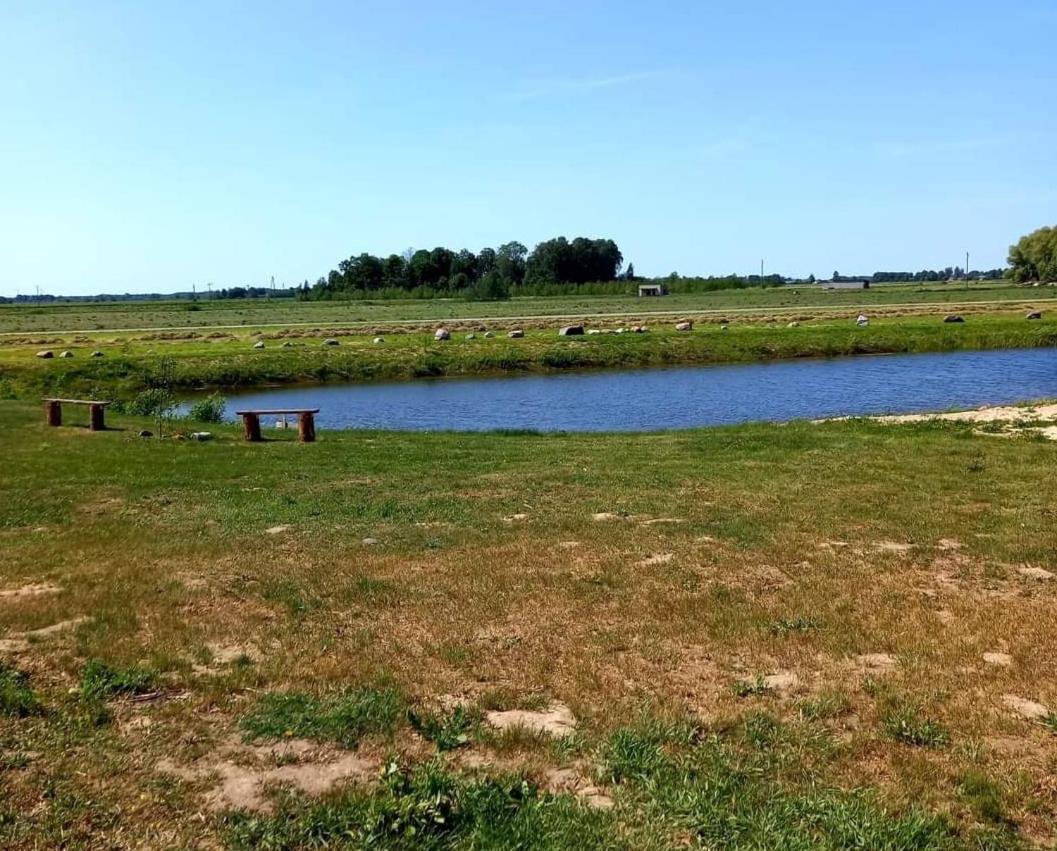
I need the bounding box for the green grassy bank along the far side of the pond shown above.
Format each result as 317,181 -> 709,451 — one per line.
0,312 -> 1057,396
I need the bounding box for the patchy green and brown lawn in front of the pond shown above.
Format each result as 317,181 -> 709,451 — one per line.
0,402 -> 1057,849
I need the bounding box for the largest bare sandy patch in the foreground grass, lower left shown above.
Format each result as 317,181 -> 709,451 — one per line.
155,739 -> 377,812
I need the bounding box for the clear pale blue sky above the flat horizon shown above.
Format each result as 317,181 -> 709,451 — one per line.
0,0 -> 1057,295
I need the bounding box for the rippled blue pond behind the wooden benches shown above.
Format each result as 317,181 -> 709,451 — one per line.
192,349 -> 1057,431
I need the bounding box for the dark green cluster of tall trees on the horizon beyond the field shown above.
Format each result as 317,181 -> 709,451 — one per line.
300,237 -> 621,298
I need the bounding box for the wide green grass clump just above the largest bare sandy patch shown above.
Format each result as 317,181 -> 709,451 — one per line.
241,687 -> 406,747
